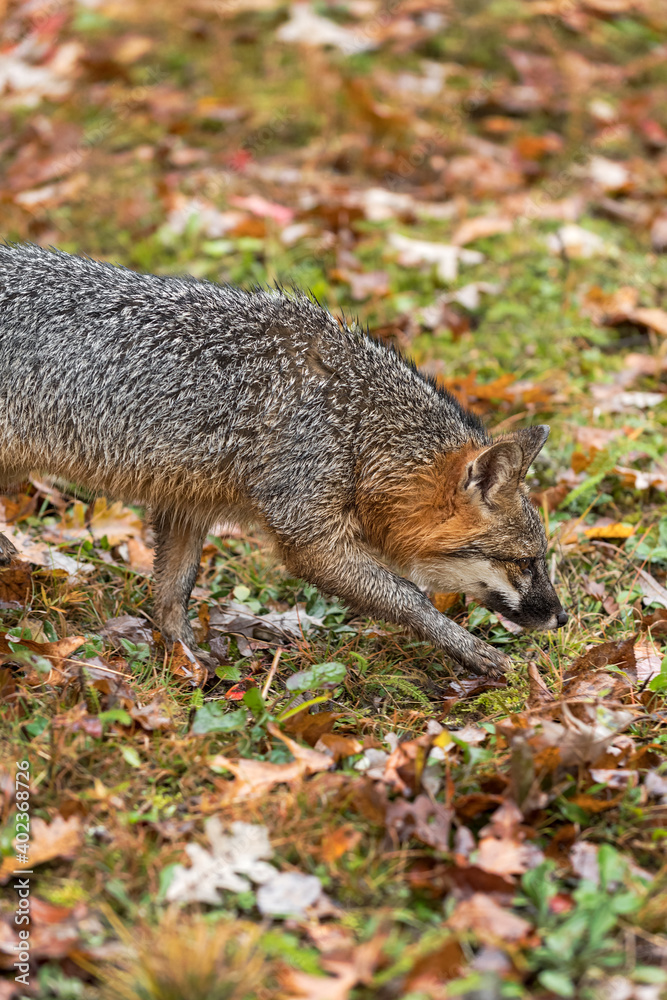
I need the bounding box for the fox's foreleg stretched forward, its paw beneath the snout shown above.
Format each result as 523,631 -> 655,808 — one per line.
286,543 -> 512,676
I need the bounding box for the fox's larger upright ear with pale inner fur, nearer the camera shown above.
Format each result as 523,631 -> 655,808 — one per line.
463,424 -> 549,503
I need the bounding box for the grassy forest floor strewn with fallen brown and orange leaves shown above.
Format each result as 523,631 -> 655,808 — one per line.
0,0 -> 667,1000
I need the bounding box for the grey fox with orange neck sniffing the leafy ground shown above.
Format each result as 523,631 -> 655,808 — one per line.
0,245 -> 567,674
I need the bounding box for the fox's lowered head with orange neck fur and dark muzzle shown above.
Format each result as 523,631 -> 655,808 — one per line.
362,426 -> 568,629
